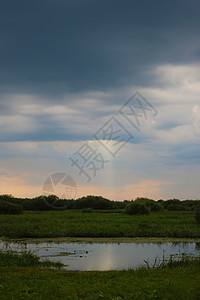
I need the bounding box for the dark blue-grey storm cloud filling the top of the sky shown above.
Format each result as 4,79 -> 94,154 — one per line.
0,0 -> 200,99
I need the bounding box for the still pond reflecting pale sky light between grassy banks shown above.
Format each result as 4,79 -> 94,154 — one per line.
0,242 -> 200,271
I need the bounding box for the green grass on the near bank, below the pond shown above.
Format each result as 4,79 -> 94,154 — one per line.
0,261 -> 200,300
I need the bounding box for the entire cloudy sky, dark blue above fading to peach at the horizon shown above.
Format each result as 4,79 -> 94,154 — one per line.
0,0 -> 200,201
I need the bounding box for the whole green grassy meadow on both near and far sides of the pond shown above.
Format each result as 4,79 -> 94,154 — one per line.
0,209 -> 200,300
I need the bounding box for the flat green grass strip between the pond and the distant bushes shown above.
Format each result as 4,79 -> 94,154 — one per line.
0,210 -> 200,238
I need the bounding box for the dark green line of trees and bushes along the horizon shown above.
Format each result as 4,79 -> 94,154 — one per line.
0,195 -> 200,214
